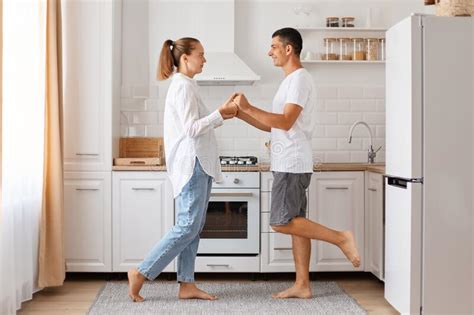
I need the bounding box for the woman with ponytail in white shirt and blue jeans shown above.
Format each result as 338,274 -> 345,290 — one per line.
128,38 -> 237,302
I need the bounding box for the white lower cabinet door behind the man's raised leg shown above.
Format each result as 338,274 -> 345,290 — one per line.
309,172 -> 365,271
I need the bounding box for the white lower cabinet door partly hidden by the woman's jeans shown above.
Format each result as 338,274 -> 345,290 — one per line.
112,171 -> 175,272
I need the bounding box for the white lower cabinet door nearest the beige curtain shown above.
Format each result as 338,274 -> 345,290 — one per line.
64,172 -> 112,272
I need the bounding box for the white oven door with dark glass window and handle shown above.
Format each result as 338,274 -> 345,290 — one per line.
198,189 -> 260,254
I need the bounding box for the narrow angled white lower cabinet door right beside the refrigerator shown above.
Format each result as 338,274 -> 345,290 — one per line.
365,172 -> 384,280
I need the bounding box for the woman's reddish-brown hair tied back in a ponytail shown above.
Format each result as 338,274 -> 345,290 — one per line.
156,37 -> 199,80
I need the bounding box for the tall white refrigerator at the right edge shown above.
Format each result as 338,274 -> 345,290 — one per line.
384,14 -> 474,314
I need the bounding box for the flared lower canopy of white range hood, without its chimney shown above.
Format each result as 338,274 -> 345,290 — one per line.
195,52 -> 260,85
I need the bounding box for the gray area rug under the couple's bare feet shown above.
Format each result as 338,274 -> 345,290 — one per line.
88,281 -> 367,315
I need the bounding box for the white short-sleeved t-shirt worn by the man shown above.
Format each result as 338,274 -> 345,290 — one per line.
271,68 -> 314,173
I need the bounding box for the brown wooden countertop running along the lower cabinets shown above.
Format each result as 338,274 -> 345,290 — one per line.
112,162 -> 385,174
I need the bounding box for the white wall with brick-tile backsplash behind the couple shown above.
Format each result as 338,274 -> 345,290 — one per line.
121,0 -> 432,162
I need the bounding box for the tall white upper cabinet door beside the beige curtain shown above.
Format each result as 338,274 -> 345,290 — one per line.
62,1 -> 120,171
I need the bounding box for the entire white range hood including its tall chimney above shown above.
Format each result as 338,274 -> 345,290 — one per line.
150,0 -> 260,85
